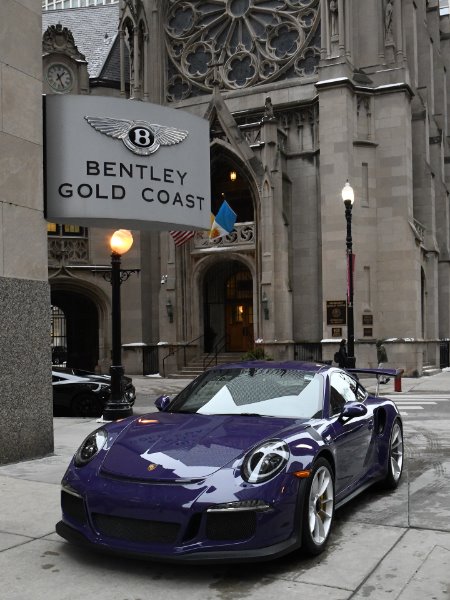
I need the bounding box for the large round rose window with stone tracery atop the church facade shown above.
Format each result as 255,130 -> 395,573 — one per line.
165,0 -> 320,100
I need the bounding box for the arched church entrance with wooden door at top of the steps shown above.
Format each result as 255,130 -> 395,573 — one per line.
203,260 -> 253,352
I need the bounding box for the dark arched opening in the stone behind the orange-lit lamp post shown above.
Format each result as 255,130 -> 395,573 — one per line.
51,290 -> 99,371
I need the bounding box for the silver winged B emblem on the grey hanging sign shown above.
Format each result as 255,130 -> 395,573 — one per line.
84,116 -> 189,156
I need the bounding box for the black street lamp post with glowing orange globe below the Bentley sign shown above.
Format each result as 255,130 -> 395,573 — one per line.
103,229 -> 133,421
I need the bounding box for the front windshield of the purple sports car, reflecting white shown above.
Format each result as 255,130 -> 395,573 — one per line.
169,367 -> 323,419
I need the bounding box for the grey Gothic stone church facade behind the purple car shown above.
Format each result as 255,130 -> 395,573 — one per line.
44,0 -> 450,374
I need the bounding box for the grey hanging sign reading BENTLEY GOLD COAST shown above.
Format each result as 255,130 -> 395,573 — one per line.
44,95 -> 211,230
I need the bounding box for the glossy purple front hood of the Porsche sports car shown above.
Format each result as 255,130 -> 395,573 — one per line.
101,413 -> 307,481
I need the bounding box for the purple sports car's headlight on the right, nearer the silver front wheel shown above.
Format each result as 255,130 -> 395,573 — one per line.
242,440 -> 290,483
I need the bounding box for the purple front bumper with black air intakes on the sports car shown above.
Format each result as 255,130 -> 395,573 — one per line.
56,475 -> 303,563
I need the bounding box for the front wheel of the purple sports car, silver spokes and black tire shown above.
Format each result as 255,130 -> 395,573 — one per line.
302,458 -> 334,556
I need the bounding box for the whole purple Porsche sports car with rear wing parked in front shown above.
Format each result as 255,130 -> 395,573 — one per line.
56,361 -> 403,562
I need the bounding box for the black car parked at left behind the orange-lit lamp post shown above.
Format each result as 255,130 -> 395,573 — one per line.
52,367 -> 136,417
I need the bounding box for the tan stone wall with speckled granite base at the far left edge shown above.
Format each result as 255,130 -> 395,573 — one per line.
0,0 -> 53,464
